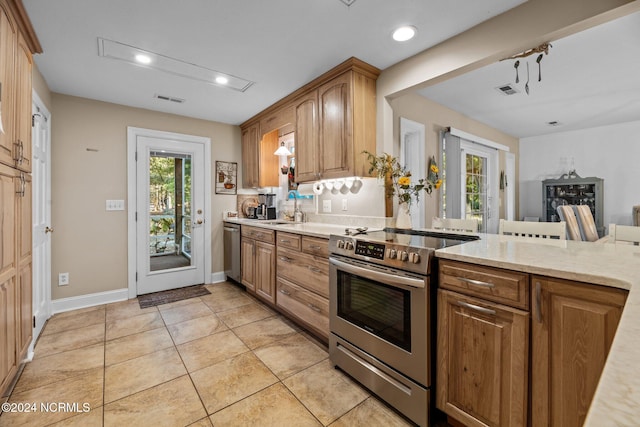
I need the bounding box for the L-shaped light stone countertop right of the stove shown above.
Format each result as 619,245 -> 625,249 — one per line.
436,234 -> 640,427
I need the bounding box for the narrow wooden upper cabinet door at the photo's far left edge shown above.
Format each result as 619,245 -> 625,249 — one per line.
0,4 -> 17,166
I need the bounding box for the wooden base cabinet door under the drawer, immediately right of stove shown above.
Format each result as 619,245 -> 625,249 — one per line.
436,289 -> 529,426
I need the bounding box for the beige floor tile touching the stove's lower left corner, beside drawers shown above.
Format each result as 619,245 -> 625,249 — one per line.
254,334 -> 329,379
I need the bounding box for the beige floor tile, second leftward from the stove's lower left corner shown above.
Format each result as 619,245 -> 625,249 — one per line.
178,331 -> 249,372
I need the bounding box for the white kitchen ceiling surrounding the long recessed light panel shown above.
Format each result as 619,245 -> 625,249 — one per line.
23,0 -> 528,124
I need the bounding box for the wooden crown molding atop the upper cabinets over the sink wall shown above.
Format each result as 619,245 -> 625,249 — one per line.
240,57 -> 380,129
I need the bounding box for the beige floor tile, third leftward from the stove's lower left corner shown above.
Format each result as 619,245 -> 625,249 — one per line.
104,328 -> 173,366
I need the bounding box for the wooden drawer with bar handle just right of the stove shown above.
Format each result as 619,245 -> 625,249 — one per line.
440,260 -> 529,310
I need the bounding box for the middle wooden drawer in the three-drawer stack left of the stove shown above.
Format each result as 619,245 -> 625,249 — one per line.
276,248 -> 329,298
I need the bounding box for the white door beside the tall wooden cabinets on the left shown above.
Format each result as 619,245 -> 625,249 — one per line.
29,92 -> 53,352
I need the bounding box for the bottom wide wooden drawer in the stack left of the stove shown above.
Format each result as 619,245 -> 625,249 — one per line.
276,278 -> 329,338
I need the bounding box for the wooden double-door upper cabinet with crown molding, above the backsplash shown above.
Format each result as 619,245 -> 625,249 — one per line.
241,58 -> 380,186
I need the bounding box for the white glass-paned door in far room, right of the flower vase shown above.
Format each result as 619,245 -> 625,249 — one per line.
460,140 -> 499,233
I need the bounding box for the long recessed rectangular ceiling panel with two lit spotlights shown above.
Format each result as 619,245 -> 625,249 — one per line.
98,37 -> 254,92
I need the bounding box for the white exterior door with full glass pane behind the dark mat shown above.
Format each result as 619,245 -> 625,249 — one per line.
130,133 -> 211,295
